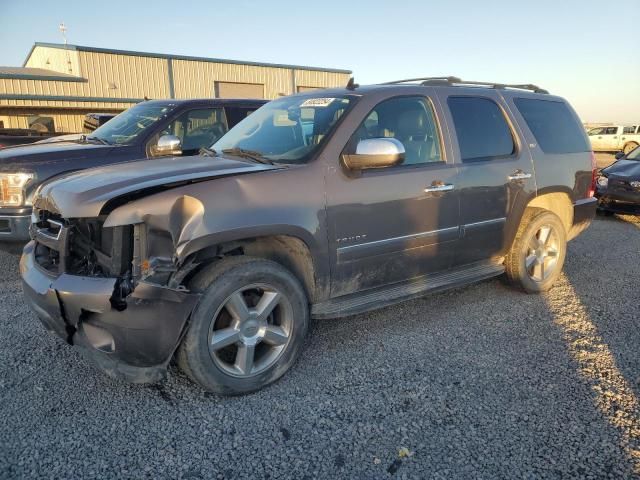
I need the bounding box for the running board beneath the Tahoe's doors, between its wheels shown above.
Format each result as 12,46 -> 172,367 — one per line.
311,263 -> 504,318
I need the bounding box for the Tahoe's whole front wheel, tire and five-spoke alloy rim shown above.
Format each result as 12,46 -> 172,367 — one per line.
178,257 -> 309,395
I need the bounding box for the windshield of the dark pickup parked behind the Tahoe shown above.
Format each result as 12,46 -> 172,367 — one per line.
87,103 -> 175,145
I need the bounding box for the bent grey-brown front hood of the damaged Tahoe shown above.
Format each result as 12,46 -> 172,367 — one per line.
33,156 -> 281,218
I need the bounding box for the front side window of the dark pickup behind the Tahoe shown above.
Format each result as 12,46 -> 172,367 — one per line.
160,108 -> 228,152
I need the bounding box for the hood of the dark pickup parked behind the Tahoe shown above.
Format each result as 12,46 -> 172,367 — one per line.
0,141 -> 118,172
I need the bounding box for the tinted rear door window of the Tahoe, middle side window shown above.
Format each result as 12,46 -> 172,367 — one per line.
447,97 -> 515,161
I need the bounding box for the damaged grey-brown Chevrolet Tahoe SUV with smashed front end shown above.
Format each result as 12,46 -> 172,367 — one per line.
20,78 -> 596,394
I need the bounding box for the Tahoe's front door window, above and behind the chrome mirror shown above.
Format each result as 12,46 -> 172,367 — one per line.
347,97 -> 442,165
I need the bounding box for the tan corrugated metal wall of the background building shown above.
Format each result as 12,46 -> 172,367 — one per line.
0,45 -> 349,131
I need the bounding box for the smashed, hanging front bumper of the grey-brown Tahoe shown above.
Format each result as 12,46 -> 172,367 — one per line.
20,242 -> 200,383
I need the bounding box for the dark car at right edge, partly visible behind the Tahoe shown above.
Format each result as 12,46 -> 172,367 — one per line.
596,148 -> 640,215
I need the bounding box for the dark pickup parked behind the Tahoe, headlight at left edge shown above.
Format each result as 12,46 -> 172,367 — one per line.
0,99 -> 266,242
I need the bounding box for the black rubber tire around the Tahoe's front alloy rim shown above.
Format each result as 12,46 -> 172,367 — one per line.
177,256 -> 309,395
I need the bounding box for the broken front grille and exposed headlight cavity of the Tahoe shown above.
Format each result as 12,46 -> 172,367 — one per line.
31,210 -> 133,277
